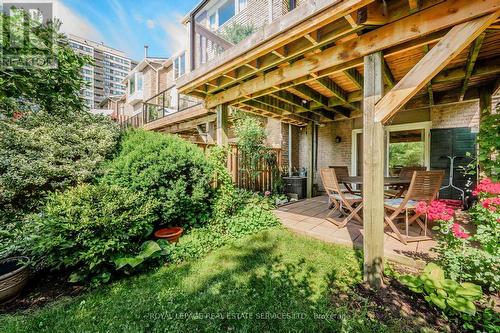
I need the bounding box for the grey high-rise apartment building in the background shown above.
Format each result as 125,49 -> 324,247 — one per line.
69,35 -> 137,109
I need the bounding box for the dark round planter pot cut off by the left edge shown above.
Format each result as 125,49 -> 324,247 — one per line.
0,257 -> 29,303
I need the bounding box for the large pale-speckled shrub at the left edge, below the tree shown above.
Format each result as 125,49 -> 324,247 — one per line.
0,111 -> 119,257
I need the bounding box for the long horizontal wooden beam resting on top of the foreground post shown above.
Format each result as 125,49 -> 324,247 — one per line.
206,0 -> 500,108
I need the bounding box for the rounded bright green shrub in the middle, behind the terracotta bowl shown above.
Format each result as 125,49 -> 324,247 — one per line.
103,130 -> 211,226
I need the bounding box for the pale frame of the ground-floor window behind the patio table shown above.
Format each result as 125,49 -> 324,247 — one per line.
351,121 -> 432,176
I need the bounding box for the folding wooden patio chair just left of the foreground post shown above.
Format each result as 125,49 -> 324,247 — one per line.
320,168 -> 363,228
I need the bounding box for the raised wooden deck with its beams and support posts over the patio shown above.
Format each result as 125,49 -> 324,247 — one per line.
178,0 -> 500,285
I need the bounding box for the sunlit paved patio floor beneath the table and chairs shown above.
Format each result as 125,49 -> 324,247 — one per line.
275,196 -> 436,267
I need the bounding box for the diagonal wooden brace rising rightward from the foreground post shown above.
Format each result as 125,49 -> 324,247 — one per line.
375,11 -> 500,122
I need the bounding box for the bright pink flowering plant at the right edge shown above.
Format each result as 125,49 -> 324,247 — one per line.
424,179 -> 500,291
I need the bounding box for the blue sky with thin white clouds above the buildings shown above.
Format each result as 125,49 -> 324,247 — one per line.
40,0 -> 199,60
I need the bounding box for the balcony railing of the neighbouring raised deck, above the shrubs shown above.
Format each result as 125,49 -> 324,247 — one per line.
121,86 -> 202,128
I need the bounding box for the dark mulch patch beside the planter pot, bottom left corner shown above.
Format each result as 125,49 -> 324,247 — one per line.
0,272 -> 85,314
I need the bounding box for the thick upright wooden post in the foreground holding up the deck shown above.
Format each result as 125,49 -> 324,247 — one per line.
363,52 -> 384,288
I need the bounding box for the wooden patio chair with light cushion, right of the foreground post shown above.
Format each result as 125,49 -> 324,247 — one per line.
384,170 -> 444,245
